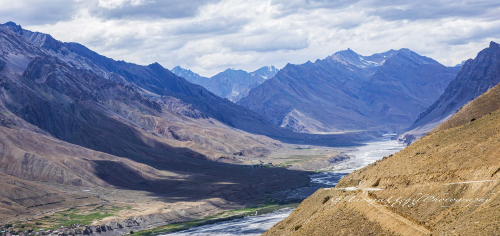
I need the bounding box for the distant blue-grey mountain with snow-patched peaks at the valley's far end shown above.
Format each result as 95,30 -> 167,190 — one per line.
238,49 -> 456,133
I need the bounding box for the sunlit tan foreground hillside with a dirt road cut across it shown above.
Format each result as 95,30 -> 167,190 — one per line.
264,73 -> 500,235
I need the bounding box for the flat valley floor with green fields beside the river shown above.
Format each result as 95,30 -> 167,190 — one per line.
4,145 -> 354,234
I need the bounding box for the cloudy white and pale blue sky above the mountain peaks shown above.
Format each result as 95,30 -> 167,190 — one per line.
0,0 -> 500,77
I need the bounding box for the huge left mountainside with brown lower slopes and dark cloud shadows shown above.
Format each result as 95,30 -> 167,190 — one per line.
0,23 -> 316,227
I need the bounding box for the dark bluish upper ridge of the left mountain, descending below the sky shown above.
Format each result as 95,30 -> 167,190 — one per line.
4,22 -> 290,138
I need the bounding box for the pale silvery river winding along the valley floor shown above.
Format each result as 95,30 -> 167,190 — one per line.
165,135 -> 406,236
